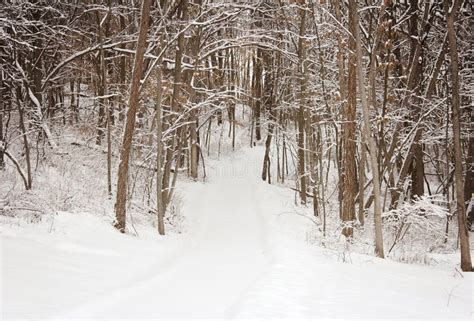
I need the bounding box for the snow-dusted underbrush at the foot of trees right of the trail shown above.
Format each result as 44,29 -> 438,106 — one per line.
307,195 -> 466,268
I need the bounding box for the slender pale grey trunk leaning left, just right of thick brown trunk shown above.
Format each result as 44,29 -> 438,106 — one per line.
349,0 -> 384,258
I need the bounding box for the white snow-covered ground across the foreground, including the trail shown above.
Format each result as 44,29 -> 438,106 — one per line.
0,147 -> 473,320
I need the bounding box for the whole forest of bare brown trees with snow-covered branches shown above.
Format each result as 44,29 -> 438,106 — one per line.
0,0 -> 474,271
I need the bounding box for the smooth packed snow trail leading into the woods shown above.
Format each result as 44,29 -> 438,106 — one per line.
66,152 -> 271,318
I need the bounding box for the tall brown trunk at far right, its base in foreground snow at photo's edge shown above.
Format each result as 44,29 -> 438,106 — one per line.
444,0 -> 473,271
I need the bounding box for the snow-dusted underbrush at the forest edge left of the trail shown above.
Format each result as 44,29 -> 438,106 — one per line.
0,127 -> 183,235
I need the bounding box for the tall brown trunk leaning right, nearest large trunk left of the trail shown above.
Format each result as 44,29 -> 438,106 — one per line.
115,0 -> 152,233
